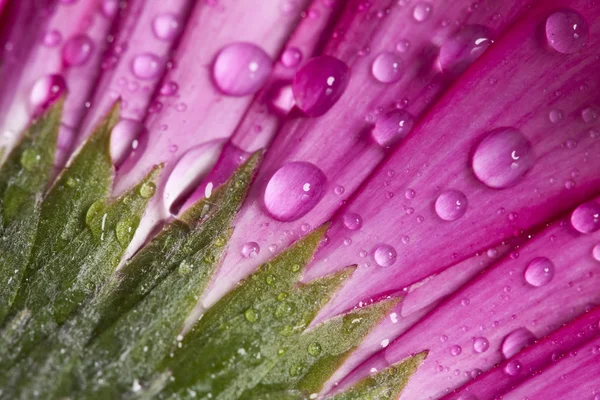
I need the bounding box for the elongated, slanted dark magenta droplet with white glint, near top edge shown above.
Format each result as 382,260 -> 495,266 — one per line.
438,25 -> 492,75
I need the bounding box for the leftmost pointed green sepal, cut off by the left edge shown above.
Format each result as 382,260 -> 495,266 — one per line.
0,100 -> 63,325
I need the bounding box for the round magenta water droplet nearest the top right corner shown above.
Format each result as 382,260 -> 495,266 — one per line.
546,10 -> 589,54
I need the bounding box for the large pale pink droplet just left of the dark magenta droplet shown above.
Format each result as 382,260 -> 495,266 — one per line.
213,42 -> 273,96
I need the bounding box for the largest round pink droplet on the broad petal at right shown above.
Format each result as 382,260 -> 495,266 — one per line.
472,127 -> 535,189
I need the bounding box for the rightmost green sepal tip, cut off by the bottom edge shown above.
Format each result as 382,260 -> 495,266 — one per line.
331,352 -> 427,400
